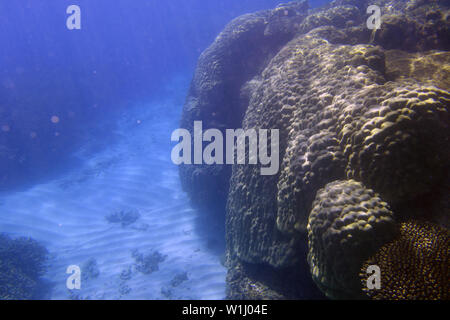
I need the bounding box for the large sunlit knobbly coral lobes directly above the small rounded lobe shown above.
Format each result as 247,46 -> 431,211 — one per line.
227,34 -> 450,266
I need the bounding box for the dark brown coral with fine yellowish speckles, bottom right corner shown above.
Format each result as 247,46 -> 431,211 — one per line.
360,221 -> 450,300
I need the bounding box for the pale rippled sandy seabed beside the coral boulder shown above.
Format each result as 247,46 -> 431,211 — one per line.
0,92 -> 226,299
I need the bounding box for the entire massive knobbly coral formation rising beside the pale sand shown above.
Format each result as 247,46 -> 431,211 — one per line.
180,0 -> 450,299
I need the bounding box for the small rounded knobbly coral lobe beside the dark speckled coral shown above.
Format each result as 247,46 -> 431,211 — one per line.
308,180 -> 396,298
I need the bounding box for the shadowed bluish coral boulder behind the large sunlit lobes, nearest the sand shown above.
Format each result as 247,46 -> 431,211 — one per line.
180,2 -> 307,218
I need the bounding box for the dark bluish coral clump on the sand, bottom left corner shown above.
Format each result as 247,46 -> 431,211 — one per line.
0,234 -> 48,300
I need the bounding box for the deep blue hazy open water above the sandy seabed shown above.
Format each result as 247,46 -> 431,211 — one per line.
0,0 -> 302,191
